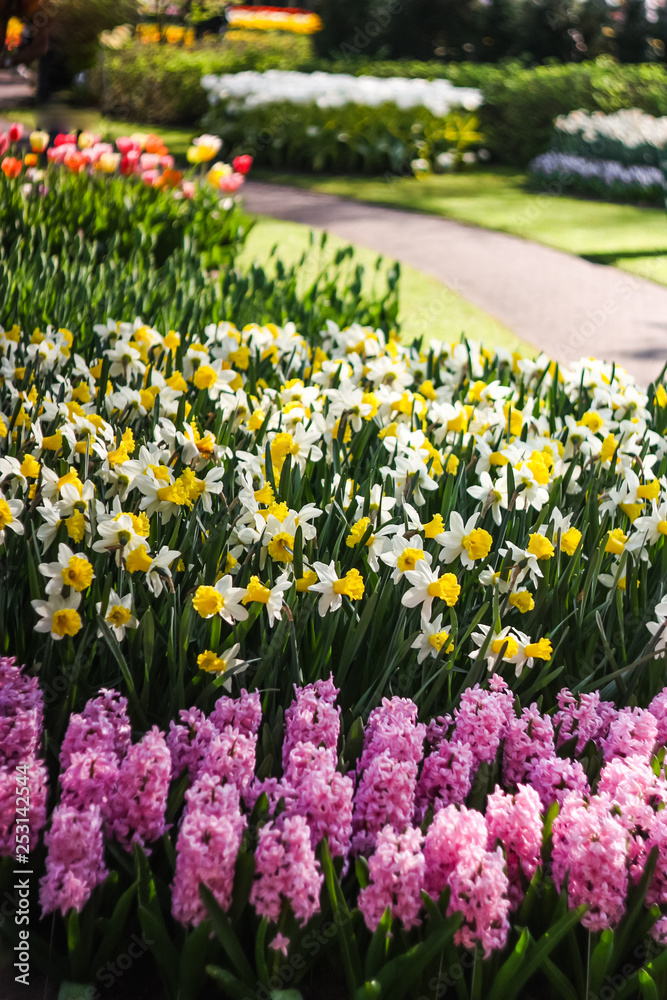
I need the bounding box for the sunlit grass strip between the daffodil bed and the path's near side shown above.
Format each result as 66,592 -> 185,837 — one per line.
239,218 -> 536,355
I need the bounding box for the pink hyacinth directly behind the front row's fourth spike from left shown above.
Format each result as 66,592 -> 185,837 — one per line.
352,750 -> 417,856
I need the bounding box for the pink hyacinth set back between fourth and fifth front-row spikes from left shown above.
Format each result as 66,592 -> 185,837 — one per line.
424,805 -> 489,899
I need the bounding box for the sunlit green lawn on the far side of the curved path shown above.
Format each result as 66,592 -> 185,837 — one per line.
254,168 -> 667,284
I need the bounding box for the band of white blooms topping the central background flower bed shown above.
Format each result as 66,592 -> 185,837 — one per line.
202,69 -> 482,116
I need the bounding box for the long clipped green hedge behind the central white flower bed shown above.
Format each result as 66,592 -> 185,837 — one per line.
92,48 -> 667,166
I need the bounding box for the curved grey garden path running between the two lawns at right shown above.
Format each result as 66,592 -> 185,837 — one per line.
244,181 -> 667,384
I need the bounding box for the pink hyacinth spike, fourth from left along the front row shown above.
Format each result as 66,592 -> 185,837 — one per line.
359,825 -> 424,931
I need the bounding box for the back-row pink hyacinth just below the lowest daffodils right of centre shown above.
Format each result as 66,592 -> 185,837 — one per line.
453,677 -> 515,768
